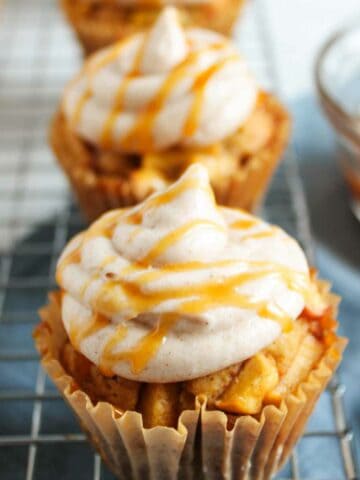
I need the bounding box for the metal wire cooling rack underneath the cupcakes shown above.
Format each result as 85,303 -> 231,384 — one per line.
0,0 -> 357,480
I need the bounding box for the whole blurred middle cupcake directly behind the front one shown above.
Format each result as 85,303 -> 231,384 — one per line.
50,7 -> 289,220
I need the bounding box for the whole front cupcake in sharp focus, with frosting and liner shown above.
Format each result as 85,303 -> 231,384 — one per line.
34,164 -> 346,479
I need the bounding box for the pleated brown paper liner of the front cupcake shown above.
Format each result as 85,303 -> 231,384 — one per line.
34,284 -> 347,480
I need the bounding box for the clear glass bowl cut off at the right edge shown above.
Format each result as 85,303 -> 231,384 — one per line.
315,20 -> 360,221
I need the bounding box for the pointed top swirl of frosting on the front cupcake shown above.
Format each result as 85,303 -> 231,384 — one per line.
115,165 -> 227,265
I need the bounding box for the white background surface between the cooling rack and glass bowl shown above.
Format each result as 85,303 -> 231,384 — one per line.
263,0 -> 360,100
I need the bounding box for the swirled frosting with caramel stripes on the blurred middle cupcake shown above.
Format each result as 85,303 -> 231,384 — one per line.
63,7 -> 257,153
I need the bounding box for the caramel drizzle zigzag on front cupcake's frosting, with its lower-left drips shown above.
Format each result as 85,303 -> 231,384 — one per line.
64,255 -> 304,376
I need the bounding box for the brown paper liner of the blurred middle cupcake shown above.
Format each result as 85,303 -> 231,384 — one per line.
50,94 -> 290,221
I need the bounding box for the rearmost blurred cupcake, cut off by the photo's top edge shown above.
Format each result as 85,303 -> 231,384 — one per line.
61,0 -> 244,55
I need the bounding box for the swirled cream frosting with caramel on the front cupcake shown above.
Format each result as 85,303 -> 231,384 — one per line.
57,164 -> 311,382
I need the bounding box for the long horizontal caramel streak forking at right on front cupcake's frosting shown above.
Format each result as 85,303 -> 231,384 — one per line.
92,265 -> 306,327
